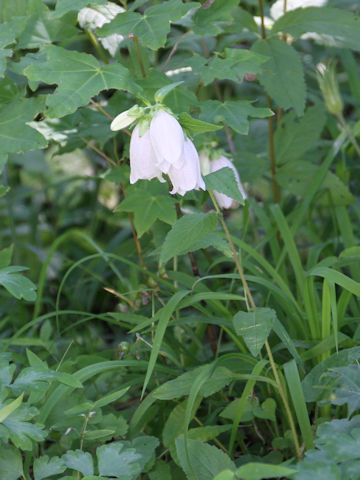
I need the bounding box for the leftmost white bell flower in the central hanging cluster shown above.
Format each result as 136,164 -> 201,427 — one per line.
130,124 -> 165,183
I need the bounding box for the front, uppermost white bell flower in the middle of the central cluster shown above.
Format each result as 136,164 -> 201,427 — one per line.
150,110 -> 185,173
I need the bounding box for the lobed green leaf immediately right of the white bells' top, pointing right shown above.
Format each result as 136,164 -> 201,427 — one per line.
200,100 -> 273,135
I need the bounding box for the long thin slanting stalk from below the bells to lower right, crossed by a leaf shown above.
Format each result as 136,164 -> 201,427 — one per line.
209,190 -> 302,459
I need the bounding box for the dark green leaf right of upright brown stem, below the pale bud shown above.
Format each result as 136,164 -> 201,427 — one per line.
274,104 -> 326,166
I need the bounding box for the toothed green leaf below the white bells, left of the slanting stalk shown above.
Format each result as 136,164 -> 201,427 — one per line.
160,213 -> 217,263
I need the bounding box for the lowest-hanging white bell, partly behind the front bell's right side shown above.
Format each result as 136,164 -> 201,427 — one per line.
169,139 -> 206,195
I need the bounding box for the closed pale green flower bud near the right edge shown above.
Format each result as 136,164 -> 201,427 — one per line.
317,62 -> 343,115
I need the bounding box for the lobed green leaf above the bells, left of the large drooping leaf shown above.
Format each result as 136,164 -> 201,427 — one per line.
188,48 -> 268,85
